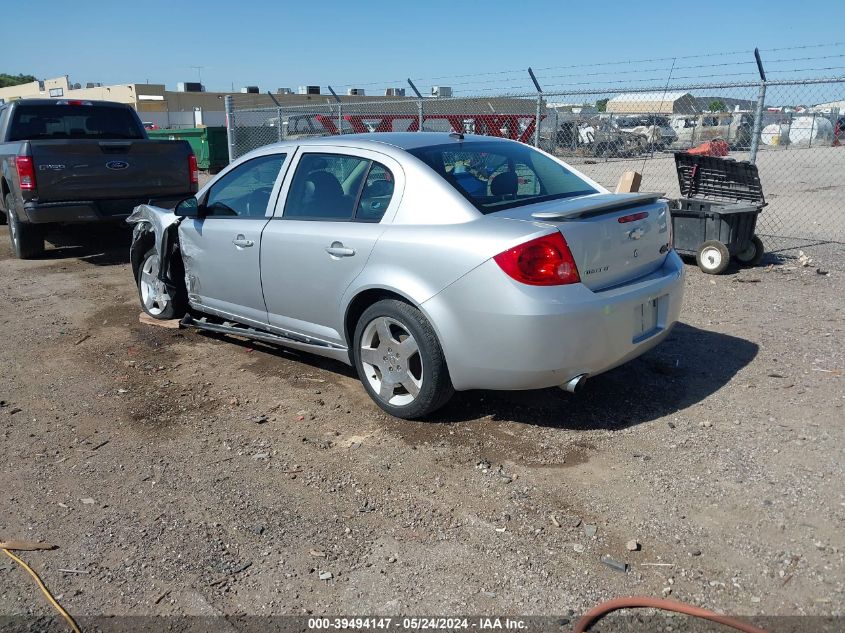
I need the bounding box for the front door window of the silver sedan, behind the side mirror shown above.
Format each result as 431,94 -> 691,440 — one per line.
205,154 -> 287,218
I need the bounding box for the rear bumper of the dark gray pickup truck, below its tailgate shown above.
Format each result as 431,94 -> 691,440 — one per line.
21,198 -> 192,224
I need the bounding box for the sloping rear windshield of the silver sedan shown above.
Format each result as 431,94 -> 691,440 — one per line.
408,142 -> 597,213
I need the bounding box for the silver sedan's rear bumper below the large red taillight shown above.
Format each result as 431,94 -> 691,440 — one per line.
421,251 -> 683,390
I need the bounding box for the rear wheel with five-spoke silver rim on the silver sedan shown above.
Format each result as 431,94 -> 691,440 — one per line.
352,299 -> 455,420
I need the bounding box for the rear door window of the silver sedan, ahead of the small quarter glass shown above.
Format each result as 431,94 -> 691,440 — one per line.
282,153 -> 371,222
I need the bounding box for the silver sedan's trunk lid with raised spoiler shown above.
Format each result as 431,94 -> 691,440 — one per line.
491,193 -> 671,290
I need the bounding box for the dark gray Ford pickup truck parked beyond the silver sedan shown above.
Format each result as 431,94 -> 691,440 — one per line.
0,99 -> 199,259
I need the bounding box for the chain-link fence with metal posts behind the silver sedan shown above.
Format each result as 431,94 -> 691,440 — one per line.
227,78 -> 845,249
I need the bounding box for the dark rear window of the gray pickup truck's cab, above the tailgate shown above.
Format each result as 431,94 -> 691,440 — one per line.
9,104 -> 144,141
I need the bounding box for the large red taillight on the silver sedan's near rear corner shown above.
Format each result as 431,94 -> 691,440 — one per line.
493,233 -> 581,286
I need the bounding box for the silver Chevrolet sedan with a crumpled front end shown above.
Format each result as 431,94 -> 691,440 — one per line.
128,133 -> 683,418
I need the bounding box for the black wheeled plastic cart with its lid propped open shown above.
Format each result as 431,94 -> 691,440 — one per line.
671,152 -> 766,275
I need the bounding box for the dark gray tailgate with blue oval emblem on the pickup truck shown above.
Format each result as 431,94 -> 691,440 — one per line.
29,139 -> 191,202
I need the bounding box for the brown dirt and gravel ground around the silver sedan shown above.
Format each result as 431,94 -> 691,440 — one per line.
0,222 -> 845,628
